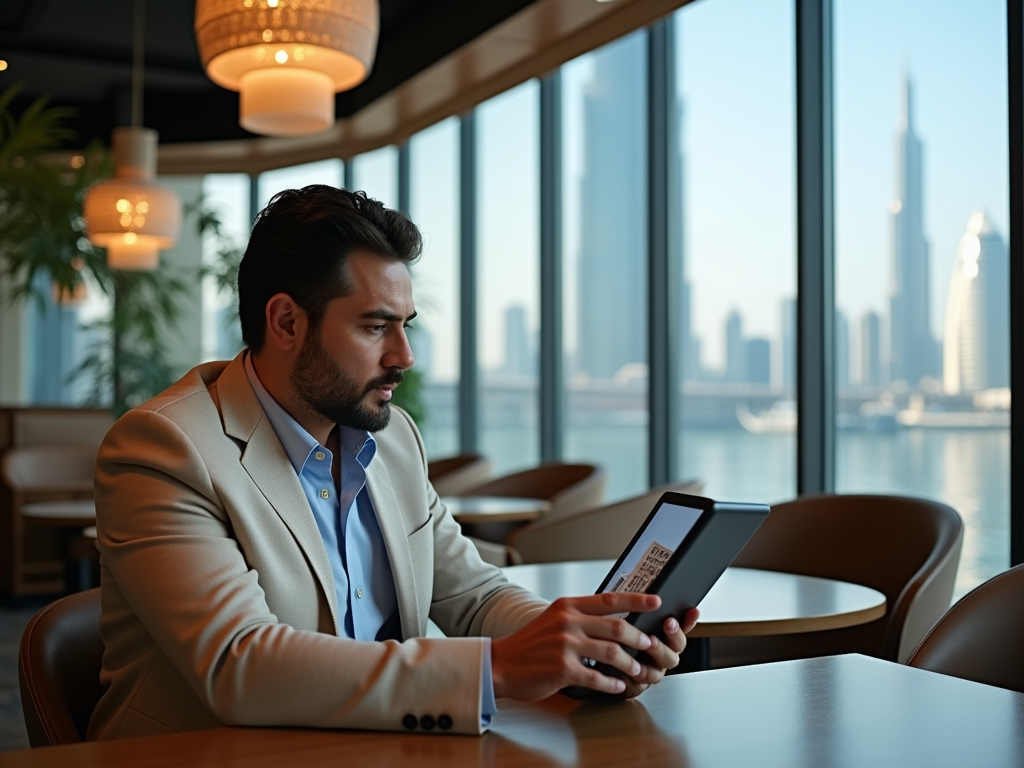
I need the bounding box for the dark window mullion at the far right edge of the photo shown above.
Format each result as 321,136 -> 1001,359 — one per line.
1007,0 -> 1024,565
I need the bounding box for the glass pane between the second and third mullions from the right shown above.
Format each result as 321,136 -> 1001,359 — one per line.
675,0 -> 797,502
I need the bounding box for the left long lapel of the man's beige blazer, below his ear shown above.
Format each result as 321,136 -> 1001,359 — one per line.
217,352 -> 344,635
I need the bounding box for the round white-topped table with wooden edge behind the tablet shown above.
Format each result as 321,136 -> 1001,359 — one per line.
502,560 -> 886,638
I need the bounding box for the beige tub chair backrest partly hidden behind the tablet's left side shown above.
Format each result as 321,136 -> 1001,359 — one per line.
507,480 -> 703,563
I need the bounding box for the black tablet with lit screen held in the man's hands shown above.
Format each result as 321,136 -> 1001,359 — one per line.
597,493 -> 769,656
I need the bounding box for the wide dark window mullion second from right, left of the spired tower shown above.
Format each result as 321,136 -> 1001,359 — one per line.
796,0 -> 836,494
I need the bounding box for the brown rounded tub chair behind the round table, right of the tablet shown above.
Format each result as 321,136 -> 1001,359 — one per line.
711,495 -> 964,667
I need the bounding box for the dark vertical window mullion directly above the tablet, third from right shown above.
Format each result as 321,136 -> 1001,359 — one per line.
647,16 -> 680,486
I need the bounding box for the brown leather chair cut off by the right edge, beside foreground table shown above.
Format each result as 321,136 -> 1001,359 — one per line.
907,565 -> 1024,693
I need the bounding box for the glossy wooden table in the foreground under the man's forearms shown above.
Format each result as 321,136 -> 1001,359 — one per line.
8,655 -> 1024,768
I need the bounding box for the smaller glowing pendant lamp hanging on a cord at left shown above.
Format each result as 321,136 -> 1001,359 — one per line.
83,0 -> 181,270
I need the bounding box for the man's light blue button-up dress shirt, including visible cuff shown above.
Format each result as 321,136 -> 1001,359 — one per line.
245,353 -> 498,725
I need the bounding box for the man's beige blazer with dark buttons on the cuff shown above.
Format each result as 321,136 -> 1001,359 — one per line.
89,355 -> 545,738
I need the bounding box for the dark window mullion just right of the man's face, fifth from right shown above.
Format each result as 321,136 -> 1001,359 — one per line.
459,112 -> 480,454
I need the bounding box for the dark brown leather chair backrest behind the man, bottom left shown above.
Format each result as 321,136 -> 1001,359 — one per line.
17,589 -> 103,746
